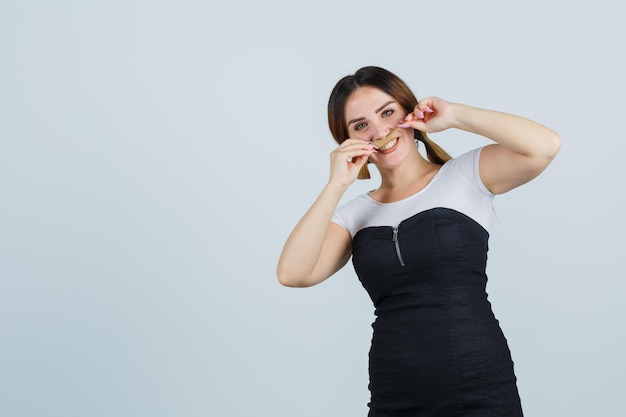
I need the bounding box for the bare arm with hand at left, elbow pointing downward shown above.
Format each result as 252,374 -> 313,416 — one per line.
276,139 -> 374,287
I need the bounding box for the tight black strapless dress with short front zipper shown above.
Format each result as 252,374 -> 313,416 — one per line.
353,208 -> 522,417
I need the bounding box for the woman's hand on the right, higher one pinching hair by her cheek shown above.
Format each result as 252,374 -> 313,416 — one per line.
400,97 -> 454,133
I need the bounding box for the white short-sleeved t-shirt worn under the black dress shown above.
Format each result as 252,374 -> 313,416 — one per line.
331,148 -> 494,238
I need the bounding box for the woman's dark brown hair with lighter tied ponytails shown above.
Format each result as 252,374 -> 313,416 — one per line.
328,67 -> 452,179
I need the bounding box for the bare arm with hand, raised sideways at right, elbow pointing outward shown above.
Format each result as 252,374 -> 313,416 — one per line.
407,97 -> 561,194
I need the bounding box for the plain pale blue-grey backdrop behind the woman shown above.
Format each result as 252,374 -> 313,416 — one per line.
0,0 -> 626,417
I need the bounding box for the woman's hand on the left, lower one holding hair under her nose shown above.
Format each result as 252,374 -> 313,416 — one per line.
329,139 -> 376,188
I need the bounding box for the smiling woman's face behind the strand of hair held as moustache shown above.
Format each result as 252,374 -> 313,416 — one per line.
345,86 -> 417,168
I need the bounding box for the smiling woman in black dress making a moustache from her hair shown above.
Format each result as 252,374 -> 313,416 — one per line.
277,67 -> 560,417
